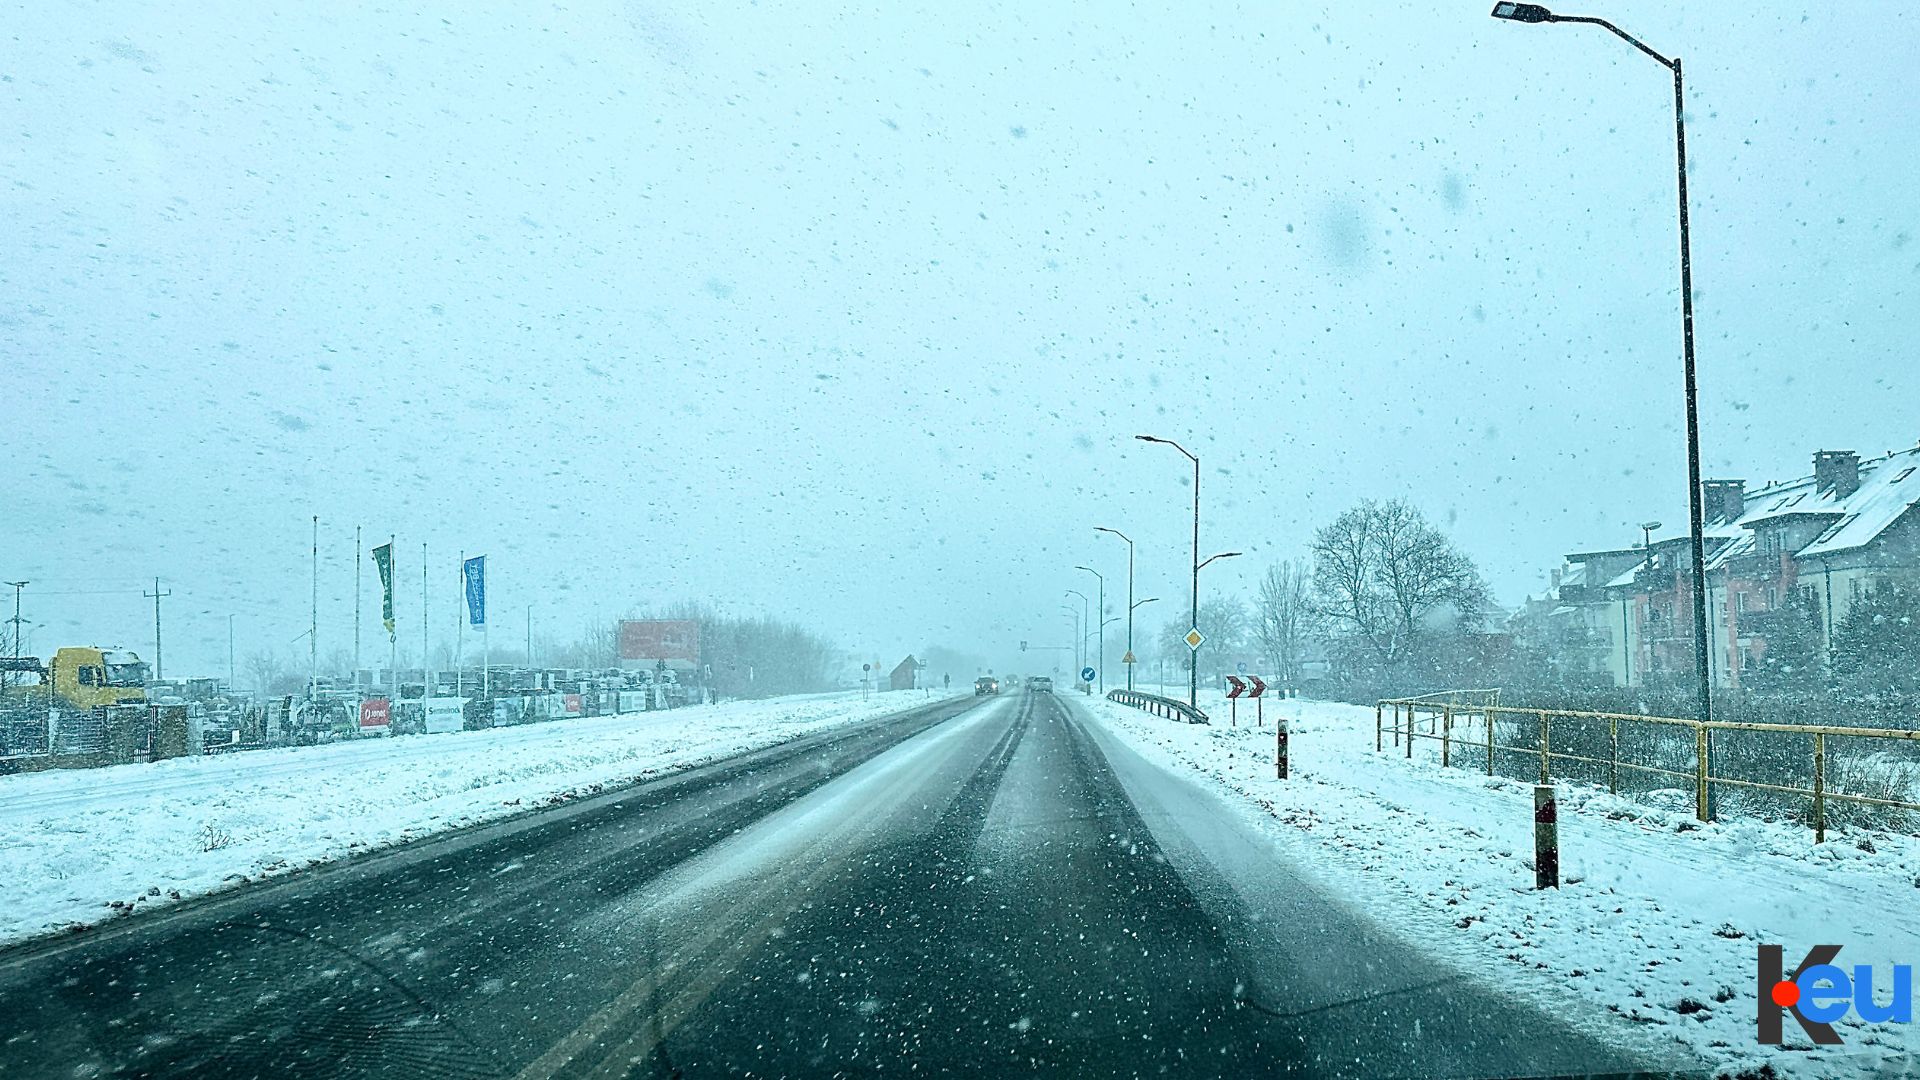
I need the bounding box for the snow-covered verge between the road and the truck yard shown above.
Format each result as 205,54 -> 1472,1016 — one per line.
0,692 -> 960,945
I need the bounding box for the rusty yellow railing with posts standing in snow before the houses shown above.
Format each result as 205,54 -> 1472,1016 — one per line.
1373,690 -> 1920,844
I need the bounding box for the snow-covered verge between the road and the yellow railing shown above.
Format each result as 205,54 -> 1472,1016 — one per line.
1081,692 -> 1920,1076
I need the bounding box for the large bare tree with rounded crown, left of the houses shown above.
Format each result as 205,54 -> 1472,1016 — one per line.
1313,500 -> 1488,663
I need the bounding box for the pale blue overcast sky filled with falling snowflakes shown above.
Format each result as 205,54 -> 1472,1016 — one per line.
0,0 -> 1920,675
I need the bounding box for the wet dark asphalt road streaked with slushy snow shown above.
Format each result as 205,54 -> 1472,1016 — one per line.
0,694 -> 1681,1080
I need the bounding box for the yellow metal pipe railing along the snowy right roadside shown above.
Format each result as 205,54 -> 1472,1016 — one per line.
1373,690 -> 1920,842
